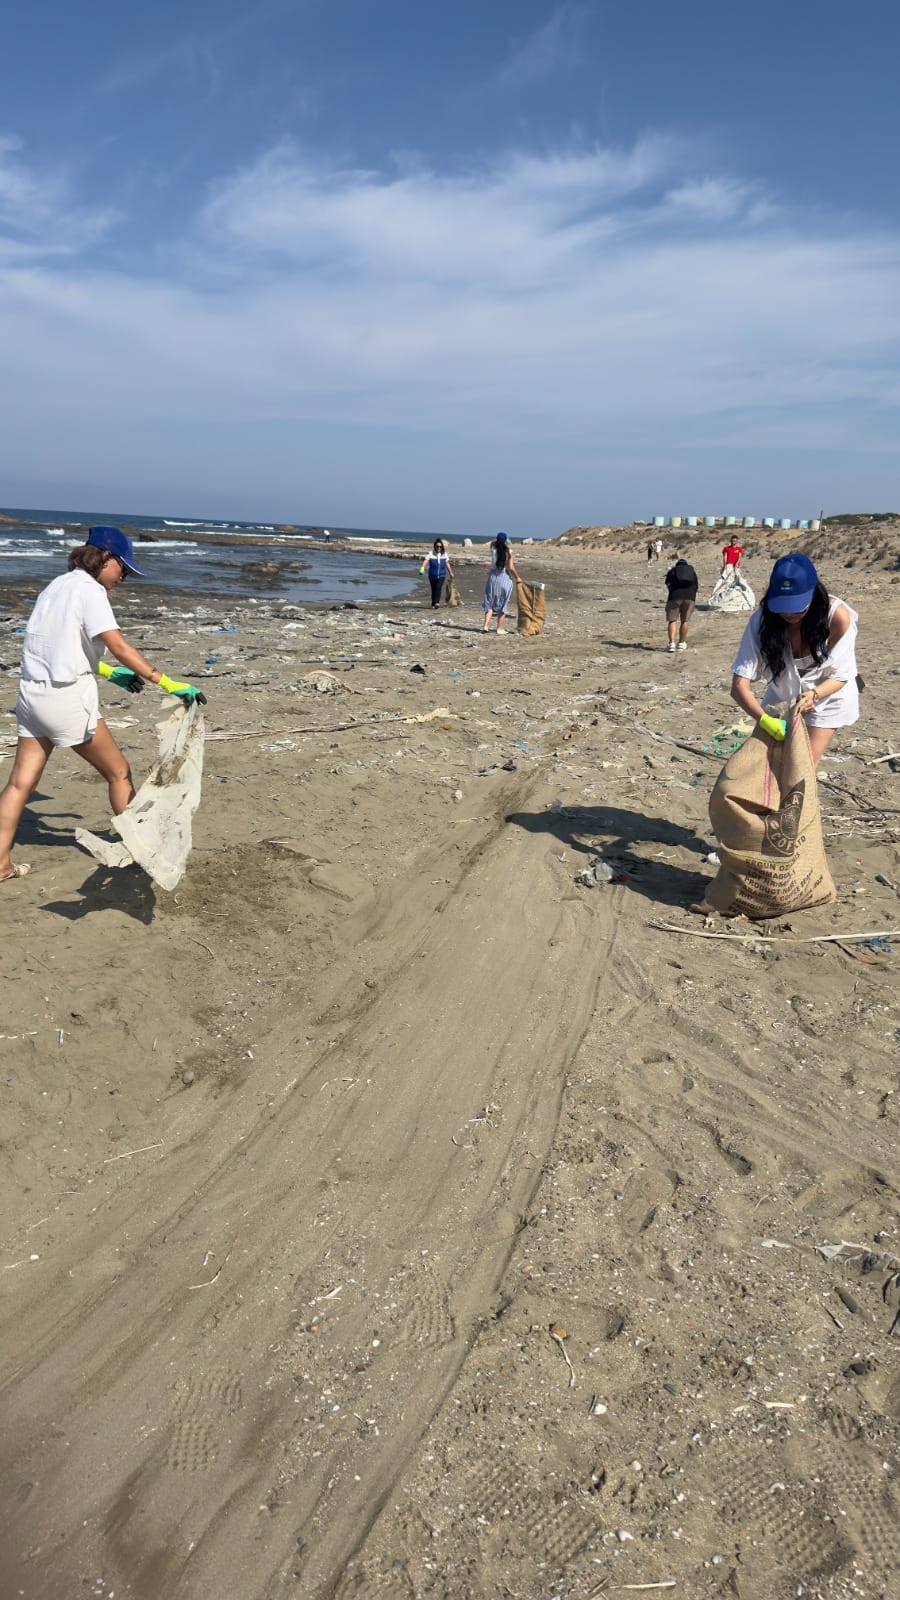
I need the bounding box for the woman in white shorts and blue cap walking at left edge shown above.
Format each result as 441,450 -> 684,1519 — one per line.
0,528 -> 205,883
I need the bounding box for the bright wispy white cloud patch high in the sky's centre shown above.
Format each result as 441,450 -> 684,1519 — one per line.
202,141 -> 671,288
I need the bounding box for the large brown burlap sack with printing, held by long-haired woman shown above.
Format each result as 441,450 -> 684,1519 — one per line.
703,710 -> 836,917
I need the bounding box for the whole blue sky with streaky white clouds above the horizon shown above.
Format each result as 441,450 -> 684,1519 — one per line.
0,0 -> 900,534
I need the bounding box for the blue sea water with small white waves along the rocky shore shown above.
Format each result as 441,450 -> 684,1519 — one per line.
0,507 -> 487,605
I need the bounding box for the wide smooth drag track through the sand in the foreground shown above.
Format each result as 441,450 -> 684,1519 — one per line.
0,768 -> 609,1600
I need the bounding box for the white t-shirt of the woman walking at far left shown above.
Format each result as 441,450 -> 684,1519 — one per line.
22,566 -> 119,683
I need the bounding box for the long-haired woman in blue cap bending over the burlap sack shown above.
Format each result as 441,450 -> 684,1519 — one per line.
732,552 -> 860,766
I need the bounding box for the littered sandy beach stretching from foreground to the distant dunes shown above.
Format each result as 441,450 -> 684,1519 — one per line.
0,549 -> 900,1600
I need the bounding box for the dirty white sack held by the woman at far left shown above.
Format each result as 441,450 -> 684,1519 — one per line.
75,704 -> 205,890
